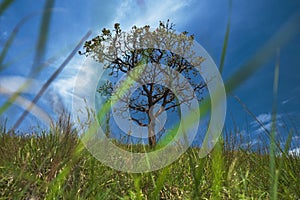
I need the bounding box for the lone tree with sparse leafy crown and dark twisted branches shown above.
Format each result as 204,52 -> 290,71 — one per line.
79,20 -> 206,147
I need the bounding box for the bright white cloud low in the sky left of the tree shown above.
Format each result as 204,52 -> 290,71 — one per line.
0,56 -> 99,124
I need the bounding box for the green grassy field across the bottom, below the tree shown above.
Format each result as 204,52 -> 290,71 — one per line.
0,114 -> 300,199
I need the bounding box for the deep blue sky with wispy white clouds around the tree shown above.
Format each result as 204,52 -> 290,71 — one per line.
0,0 -> 300,152
